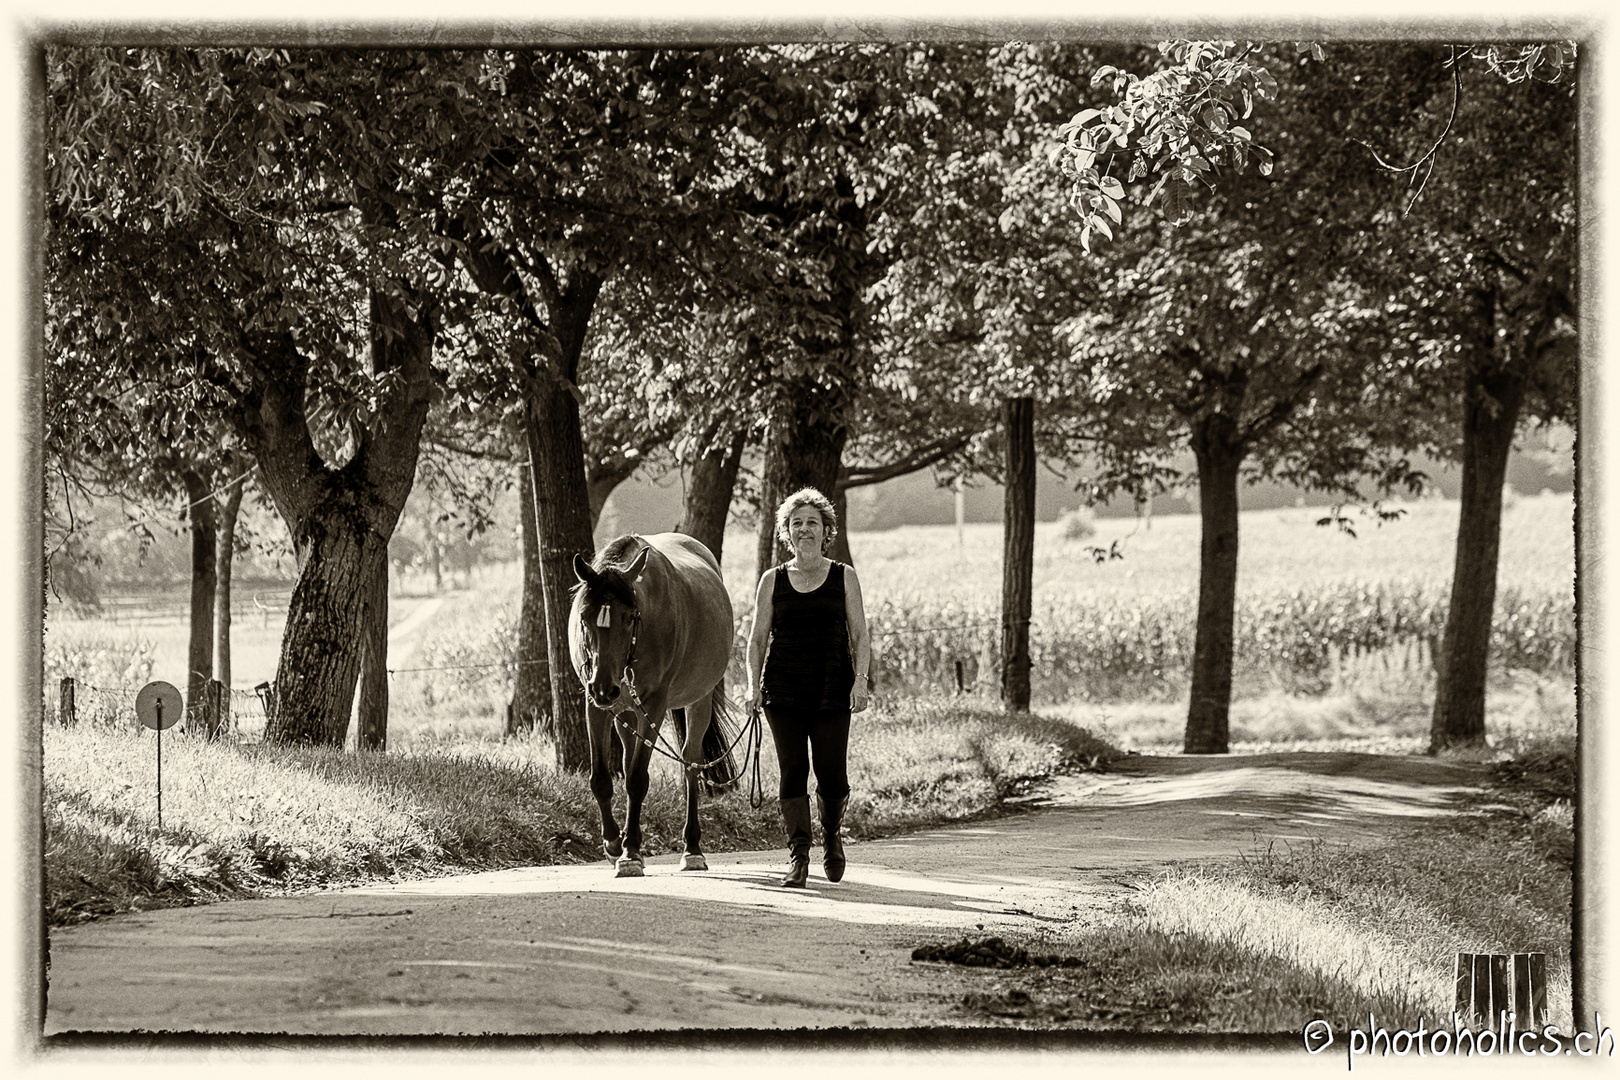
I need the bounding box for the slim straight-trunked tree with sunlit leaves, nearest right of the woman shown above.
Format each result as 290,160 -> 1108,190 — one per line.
878,44 -> 1140,711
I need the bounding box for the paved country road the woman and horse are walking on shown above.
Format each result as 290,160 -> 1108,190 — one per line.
45,755 -> 1479,1035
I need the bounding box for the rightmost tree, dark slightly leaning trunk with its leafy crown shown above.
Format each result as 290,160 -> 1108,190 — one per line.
1347,55 -> 1578,753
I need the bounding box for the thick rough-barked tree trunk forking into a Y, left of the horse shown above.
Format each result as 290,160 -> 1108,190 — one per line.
248,290 -> 436,746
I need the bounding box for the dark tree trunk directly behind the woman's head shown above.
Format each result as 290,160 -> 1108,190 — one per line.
755,382 -> 849,578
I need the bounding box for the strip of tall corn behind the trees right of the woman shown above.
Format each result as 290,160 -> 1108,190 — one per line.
868,581 -> 1575,701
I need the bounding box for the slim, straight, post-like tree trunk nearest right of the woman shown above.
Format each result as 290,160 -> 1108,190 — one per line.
1001,397 -> 1035,712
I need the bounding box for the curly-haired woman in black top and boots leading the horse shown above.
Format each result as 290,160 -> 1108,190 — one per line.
748,487 -> 872,889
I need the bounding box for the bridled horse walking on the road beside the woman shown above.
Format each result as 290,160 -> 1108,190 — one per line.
569,533 -> 739,878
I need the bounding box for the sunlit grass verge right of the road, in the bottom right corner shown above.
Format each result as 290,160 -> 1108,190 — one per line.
920,737 -> 1575,1036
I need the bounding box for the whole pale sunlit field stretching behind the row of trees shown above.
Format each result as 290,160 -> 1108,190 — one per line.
45,494 -> 1575,751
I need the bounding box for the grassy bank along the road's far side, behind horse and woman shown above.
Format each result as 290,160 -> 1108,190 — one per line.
44,698 -> 1115,925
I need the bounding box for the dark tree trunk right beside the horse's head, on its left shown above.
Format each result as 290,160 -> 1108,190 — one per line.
525,270 -> 601,772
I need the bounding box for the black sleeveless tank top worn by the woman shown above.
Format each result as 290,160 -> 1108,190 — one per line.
763,562 -> 855,711
